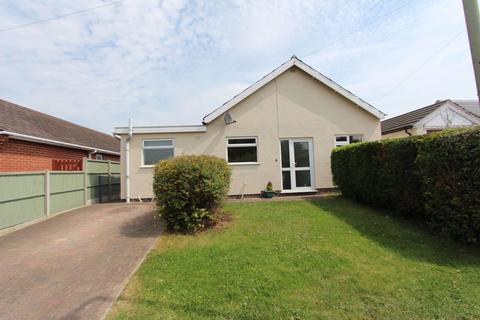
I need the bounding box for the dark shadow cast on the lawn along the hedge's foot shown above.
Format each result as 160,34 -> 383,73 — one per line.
310,196 -> 480,266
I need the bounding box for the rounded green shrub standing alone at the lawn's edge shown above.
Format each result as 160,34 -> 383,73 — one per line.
153,155 -> 231,232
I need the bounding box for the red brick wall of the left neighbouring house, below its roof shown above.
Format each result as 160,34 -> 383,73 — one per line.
0,135 -> 88,172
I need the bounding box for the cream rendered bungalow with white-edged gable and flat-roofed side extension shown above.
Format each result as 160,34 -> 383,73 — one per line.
114,56 -> 384,199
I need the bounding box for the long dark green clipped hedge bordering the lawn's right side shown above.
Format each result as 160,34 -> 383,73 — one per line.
331,127 -> 480,244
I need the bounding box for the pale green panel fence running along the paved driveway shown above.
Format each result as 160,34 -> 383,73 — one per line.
0,159 -> 120,230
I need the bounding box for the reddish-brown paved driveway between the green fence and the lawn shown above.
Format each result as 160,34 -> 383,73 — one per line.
0,203 -> 160,320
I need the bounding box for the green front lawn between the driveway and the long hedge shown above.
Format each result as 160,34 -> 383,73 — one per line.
109,197 -> 480,319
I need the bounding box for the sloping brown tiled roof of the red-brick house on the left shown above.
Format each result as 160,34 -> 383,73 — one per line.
0,99 -> 120,152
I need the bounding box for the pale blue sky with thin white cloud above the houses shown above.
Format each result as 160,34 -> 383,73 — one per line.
0,0 -> 476,133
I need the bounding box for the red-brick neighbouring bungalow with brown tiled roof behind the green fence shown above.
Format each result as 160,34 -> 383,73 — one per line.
0,99 -> 120,172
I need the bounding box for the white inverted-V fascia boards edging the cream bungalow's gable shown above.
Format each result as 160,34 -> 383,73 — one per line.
203,56 -> 386,124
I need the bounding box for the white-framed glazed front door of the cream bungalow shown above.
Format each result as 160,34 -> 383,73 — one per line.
280,139 -> 315,192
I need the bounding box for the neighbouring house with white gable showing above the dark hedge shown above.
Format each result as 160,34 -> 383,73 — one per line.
382,100 -> 480,139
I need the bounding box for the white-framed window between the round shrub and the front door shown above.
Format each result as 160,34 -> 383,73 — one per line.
227,137 -> 258,164
